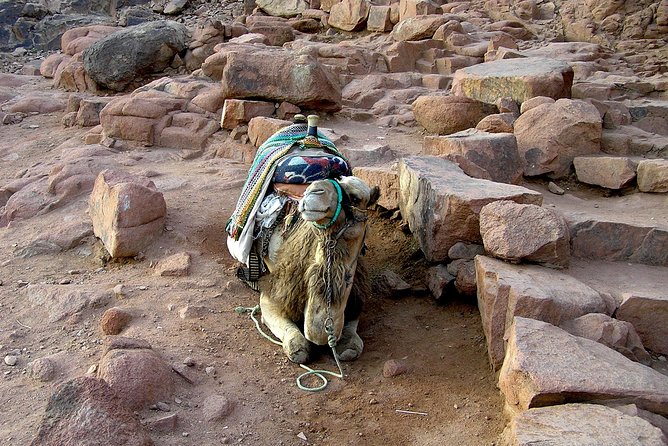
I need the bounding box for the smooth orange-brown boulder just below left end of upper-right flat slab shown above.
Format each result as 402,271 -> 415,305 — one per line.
412,95 -> 497,135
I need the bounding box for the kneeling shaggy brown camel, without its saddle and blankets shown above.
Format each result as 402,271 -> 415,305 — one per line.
256,176 -> 379,364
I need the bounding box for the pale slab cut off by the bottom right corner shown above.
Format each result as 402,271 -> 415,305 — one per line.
501,404 -> 666,446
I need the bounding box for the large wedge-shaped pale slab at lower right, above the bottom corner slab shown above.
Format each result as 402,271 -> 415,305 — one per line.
499,317 -> 668,416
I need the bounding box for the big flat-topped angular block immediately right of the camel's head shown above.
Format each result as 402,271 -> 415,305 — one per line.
399,156 -> 543,262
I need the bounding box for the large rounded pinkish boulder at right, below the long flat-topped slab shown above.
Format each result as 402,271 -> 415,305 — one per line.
514,99 -> 603,179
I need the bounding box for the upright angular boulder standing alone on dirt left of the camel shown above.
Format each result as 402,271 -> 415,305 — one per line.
89,170 -> 167,258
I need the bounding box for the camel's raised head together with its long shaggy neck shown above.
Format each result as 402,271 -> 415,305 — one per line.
299,177 -> 379,345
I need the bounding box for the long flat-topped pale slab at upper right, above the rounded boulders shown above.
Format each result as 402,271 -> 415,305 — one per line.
452,57 -> 573,104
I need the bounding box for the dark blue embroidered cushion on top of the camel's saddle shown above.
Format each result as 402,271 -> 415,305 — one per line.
273,154 -> 351,184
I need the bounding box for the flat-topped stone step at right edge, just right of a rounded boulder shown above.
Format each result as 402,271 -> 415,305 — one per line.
532,187 -> 668,266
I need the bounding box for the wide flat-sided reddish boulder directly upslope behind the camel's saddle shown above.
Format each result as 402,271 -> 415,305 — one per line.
202,44 -> 341,111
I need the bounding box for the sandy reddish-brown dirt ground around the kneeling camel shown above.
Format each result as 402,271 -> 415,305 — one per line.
0,84 -> 506,446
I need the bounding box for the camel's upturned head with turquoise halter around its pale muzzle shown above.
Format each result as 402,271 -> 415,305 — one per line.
299,176 -> 379,228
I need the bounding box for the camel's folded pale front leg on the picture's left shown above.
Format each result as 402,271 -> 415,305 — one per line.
260,293 -> 311,364
